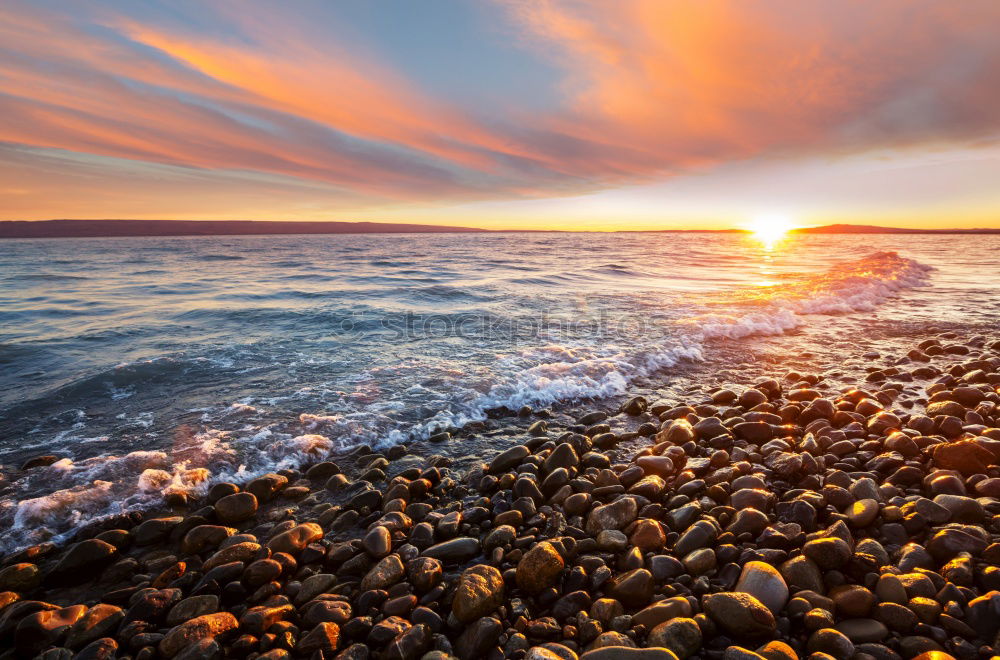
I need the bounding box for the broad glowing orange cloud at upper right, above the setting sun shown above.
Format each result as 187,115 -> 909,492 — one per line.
506,0 -> 1000,166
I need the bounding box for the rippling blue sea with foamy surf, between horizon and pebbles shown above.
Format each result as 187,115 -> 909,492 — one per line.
0,233 -> 1000,550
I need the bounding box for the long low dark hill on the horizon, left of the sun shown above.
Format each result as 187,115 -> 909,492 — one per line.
0,220 -> 487,238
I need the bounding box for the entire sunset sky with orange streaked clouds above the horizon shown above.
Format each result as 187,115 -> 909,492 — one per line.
0,0 -> 1000,229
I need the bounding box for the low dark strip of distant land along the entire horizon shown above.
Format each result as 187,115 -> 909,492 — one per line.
0,219 -> 1000,239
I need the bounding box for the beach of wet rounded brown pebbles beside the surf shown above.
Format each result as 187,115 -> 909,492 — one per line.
0,333 -> 1000,660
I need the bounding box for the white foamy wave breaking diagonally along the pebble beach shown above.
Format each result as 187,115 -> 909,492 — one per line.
0,252 -> 930,549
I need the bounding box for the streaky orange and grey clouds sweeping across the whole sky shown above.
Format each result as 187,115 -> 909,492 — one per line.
0,0 -> 1000,222
